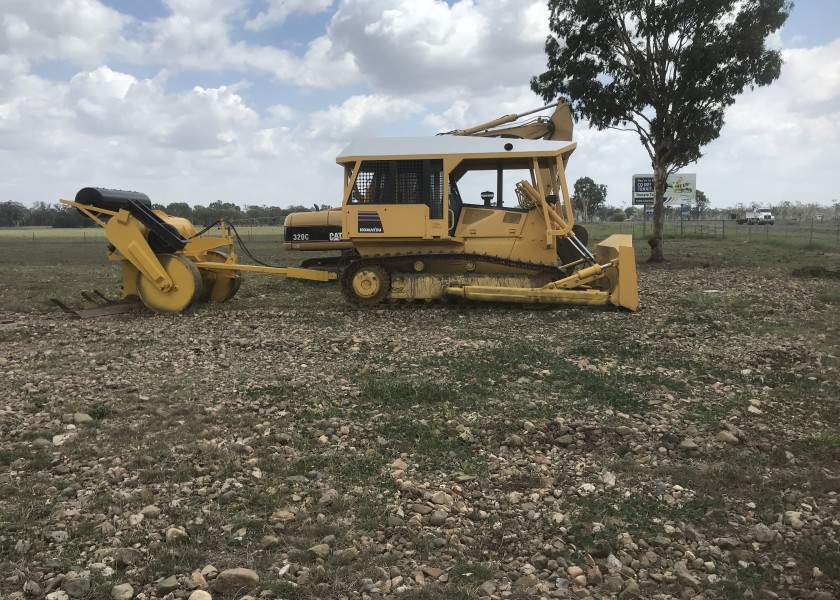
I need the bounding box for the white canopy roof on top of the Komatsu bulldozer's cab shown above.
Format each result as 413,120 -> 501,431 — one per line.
336,135 -> 576,163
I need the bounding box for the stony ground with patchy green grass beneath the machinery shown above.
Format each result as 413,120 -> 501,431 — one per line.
0,225 -> 840,600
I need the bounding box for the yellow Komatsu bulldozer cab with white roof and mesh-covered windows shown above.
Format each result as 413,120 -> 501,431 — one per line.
337,136 -> 575,247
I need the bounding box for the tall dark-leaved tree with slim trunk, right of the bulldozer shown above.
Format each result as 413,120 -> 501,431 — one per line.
531,0 -> 793,262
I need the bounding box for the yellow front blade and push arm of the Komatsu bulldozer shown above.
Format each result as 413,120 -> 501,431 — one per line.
446,234 -> 639,310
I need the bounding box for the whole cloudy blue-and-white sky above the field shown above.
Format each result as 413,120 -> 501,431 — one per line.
0,0 -> 840,207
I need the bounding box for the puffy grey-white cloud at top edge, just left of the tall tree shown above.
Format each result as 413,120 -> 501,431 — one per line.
329,0 -> 548,100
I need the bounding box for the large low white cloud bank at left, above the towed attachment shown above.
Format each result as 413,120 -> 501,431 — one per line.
0,61 -> 293,202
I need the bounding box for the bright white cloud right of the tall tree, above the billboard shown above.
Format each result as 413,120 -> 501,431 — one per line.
697,39 -> 840,205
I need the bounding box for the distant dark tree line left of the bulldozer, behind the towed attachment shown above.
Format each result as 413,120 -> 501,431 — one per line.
0,200 -> 316,228
